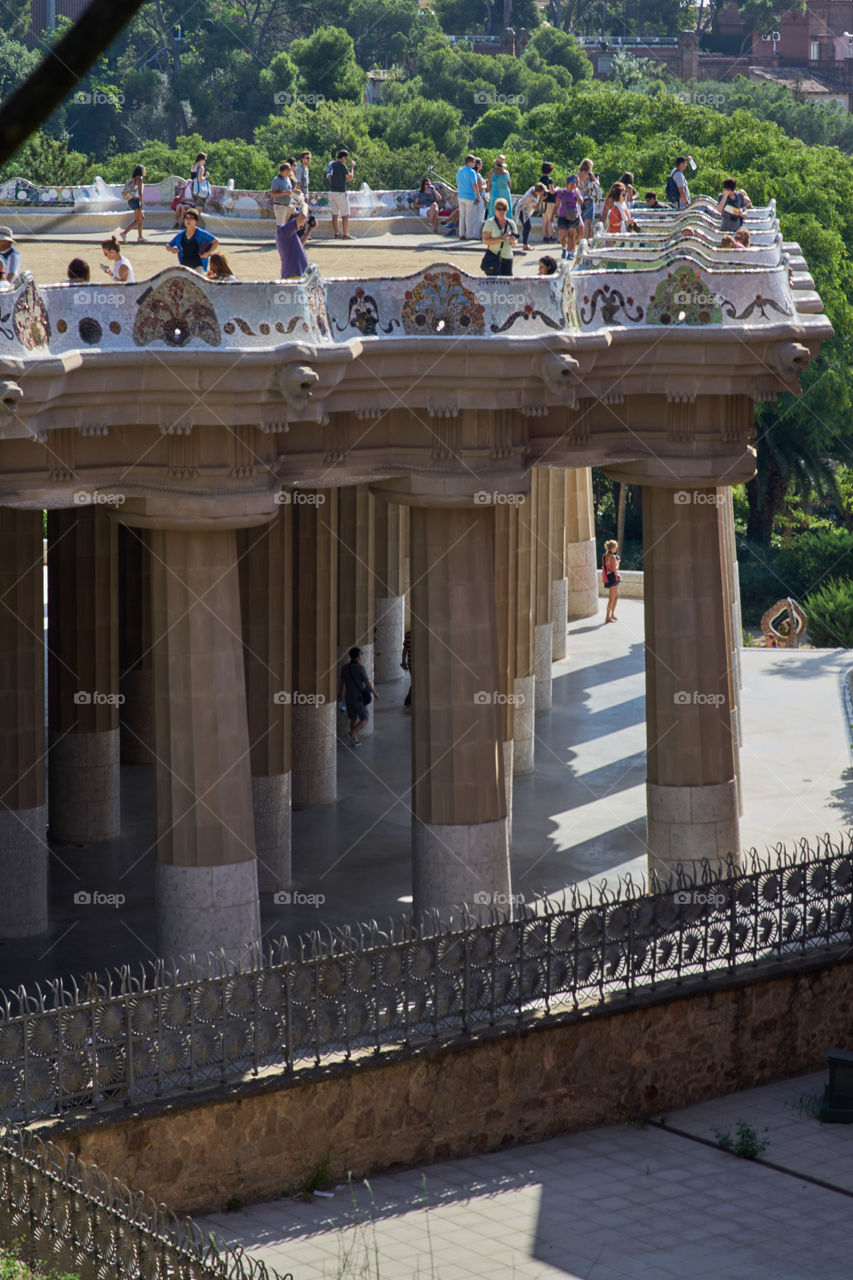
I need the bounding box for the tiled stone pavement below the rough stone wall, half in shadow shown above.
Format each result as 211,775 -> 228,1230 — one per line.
199,1071 -> 853,1280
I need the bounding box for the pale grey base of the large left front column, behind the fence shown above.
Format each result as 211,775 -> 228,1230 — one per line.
155,859 -> 260,968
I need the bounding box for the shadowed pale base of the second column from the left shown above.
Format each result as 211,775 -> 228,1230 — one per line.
47,728 -> 122,845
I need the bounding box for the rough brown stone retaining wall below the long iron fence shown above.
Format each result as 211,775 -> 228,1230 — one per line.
46,952 -> 853,1213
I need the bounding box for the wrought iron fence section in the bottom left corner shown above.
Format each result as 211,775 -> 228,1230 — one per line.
0,1129 -> 292,1280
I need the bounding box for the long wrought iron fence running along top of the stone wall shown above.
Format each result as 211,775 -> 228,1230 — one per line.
0,833 -> 853,1121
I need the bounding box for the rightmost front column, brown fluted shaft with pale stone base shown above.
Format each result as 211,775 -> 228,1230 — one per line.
643,485 -> 739,874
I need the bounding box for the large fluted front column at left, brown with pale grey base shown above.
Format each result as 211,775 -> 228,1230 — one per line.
150,519 -> 260,963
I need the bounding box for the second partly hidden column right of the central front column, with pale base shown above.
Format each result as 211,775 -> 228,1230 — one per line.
512,494 -> 535,777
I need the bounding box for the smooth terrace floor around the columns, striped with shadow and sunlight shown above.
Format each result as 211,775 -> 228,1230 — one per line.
0,599 -> 853,988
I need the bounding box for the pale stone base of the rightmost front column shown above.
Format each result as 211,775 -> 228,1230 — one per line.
646,778 -> 740,878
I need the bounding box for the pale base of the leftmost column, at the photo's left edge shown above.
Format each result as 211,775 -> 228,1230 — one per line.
0,804 -> 49,938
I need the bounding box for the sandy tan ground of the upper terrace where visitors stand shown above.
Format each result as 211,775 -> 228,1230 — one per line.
17,230 -> 504,284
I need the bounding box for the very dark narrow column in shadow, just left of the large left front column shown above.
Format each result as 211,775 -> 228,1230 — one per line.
118,525 -> 154,764
